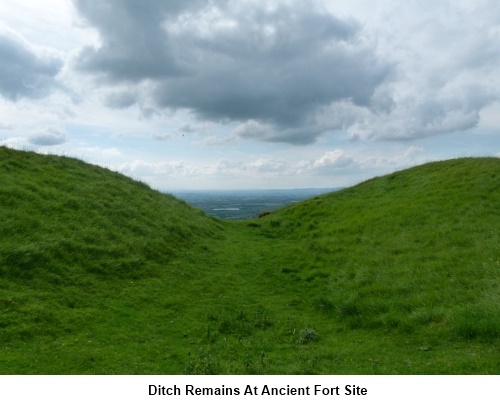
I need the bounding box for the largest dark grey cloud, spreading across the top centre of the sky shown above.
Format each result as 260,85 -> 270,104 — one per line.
74,0 -> 392,144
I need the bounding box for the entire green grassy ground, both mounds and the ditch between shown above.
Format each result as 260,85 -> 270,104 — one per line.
0,148 -> 500,374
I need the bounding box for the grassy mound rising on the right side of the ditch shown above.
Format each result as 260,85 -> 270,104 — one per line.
256,159 -> 500,341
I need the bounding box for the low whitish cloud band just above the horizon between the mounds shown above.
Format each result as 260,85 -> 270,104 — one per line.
110,142 -> 430,189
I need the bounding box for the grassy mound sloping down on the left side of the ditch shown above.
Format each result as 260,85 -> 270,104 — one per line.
0,148 -> 220,285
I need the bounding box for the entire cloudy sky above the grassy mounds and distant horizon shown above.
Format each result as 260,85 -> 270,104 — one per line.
0,0 -> 500,191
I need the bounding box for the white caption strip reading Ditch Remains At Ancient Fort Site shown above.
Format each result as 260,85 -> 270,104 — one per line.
0,376 -> 500,405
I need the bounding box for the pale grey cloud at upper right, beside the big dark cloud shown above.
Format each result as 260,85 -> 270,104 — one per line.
350,0 -> 500,140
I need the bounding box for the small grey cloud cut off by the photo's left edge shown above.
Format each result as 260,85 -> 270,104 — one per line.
0,29 -> 63,101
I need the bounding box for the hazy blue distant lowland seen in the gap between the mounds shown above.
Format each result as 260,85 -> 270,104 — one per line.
171,188 -> 339,219
